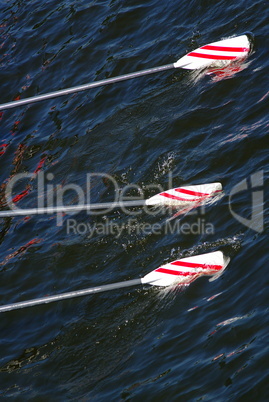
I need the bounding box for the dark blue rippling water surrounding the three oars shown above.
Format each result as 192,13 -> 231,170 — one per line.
0,0 -> 269,401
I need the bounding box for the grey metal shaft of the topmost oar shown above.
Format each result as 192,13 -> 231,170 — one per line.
0,63 -> 175,110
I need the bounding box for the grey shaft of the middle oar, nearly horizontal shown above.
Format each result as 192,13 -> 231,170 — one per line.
0,200 -> 146,218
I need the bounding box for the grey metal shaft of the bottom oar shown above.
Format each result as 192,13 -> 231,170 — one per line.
0,278 -> 142,313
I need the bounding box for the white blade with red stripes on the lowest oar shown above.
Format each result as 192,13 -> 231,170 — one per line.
142,251 -> 230,286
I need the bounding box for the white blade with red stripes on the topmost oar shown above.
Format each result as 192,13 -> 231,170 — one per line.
174,35 -> 251,70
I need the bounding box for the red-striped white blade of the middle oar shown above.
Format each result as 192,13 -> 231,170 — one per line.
146,183 -> 222,206
